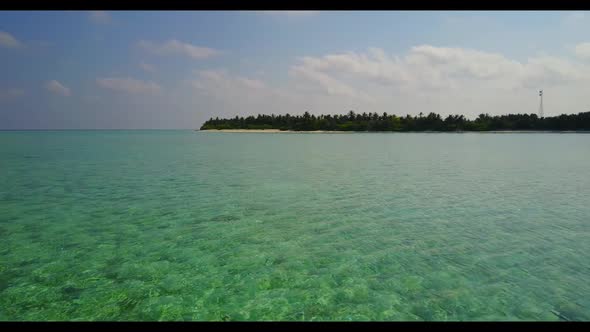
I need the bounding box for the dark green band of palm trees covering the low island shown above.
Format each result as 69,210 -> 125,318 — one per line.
201,111 -> 590,131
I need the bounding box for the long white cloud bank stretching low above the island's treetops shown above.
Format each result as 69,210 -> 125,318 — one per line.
125,45 -> 590,125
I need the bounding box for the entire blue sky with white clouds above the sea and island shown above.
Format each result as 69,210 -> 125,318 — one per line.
0,11 -> 590,129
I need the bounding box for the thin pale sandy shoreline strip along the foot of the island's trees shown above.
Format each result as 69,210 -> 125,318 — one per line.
195,129 -> 590,134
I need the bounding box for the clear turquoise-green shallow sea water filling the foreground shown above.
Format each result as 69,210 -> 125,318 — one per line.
0,131 -> 590,320
